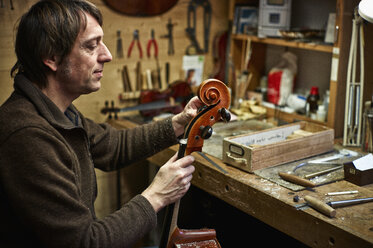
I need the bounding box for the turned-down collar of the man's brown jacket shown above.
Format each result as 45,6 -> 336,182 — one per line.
14,73 -> 82,129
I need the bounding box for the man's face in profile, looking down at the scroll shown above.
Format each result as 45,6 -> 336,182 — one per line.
56,11 -> 112,99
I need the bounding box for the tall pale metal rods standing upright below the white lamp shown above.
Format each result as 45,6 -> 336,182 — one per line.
343,9 -> 364,146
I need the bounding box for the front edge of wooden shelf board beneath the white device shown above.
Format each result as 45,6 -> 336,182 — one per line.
232,34 -> 333,53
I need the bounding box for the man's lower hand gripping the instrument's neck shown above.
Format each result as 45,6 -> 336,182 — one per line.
142,154 -> 194,212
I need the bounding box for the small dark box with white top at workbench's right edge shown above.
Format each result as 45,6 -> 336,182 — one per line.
344,153 -> 373,186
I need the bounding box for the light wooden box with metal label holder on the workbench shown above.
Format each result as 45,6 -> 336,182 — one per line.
223,121 -> 334,172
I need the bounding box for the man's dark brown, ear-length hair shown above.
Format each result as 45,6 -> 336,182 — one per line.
11,0 -> 102,88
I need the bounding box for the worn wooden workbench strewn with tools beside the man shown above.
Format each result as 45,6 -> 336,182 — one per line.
111,117 -> 373,247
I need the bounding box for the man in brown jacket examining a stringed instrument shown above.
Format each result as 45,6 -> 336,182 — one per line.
0,0 -> 201,248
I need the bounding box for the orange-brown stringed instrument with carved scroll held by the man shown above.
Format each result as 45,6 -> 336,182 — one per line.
159,79 -> 231,248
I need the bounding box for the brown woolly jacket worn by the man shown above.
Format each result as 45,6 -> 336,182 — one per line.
0,75 -> 177,248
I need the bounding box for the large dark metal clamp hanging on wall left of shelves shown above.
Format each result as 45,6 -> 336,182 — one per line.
185,0 -> 211,55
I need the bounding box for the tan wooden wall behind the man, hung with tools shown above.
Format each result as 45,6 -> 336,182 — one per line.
0,0 -> 228,216
